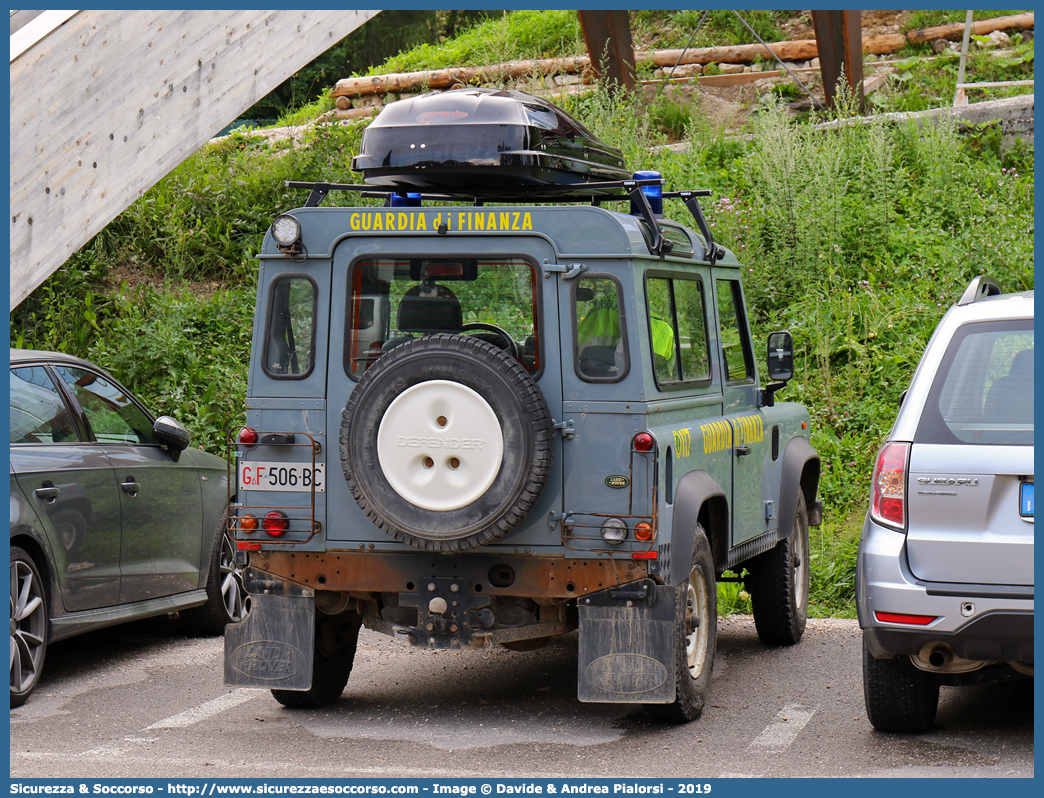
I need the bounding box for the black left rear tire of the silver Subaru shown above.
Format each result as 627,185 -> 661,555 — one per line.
862,644 -> 939,733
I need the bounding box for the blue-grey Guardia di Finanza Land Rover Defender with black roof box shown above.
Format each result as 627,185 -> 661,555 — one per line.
224,89 -> 822,720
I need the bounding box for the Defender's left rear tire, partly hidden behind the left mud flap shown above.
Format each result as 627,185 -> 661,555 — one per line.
271,614 -> 362,709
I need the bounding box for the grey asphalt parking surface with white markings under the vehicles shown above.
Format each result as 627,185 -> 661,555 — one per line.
10,617 -> 1034,778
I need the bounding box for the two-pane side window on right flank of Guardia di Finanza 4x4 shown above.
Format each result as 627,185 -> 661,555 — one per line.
645,277 -> 711,385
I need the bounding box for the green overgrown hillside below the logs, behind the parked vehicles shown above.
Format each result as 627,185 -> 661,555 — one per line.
10,10 -> 1034,614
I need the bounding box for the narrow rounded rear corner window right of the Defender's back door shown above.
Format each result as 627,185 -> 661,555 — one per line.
573,277 -> 627,382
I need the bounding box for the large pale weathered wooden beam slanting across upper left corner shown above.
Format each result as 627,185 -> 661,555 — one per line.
9,10 -> 378,307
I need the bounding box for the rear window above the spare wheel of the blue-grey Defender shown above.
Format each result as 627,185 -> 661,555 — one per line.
345,257 -> 540,377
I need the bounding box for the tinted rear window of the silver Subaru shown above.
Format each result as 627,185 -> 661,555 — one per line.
915,319 -> 1034,446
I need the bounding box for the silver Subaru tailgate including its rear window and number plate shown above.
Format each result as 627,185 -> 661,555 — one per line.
906,319 -> 1034,585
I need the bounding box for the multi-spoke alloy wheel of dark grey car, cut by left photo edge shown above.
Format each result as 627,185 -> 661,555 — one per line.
10,546 -> 48,707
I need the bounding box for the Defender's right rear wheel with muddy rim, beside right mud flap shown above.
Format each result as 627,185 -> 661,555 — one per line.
653,524 -> 717,723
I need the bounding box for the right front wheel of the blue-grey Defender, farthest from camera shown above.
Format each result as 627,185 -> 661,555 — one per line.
745,491 -> 808,646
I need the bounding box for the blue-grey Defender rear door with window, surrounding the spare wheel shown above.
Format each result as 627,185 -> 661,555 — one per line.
326,230 -> 562,548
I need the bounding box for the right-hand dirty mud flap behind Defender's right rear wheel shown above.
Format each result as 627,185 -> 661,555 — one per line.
576,579 -> 678,704
